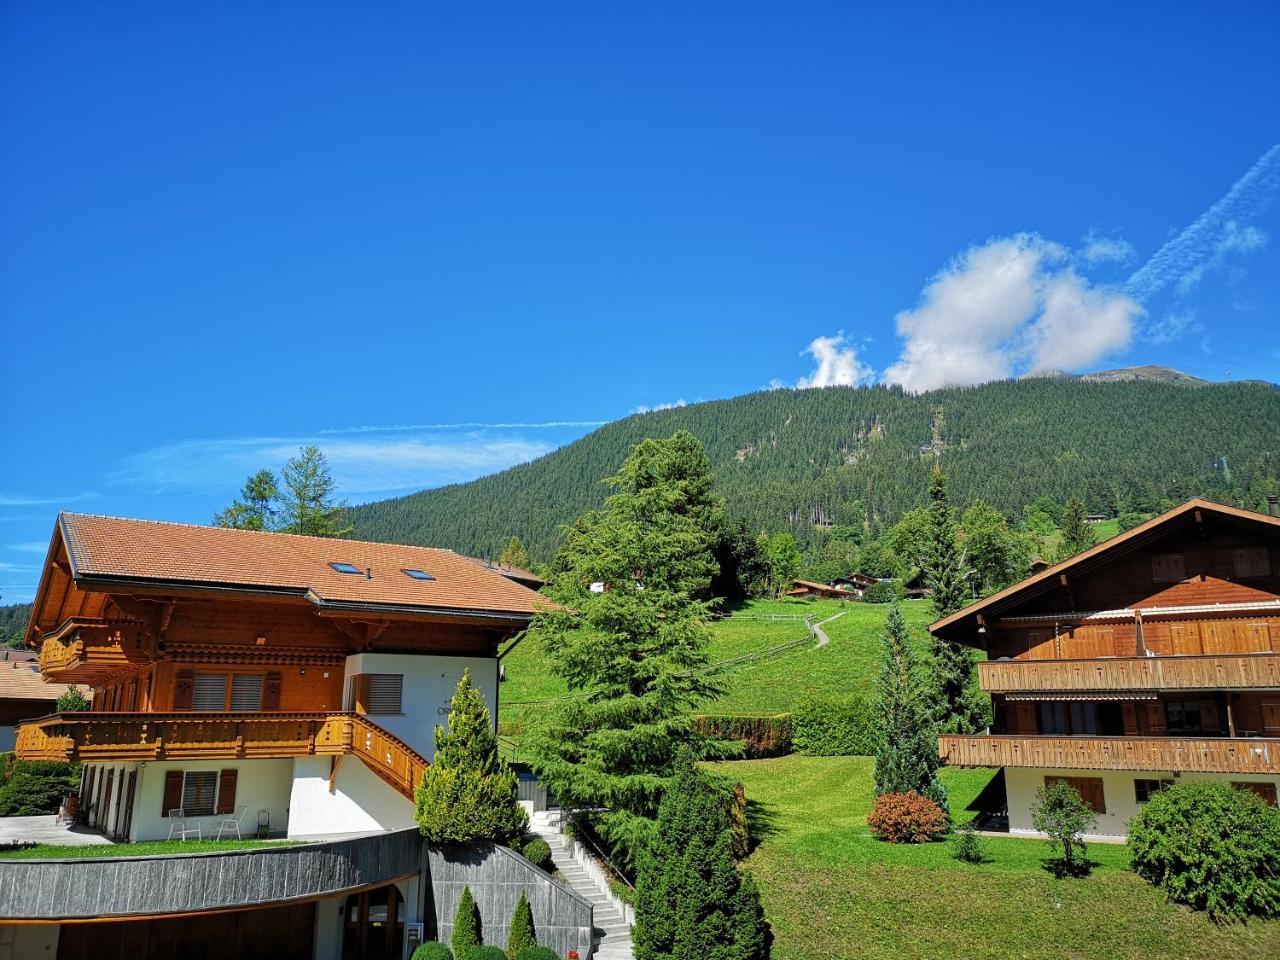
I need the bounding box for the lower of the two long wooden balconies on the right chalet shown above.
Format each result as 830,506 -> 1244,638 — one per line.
938,735 -> 1280,773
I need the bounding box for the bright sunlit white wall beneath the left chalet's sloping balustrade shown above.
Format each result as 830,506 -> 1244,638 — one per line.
289,756 -> 416,838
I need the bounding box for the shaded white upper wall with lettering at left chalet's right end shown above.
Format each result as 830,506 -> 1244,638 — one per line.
346,653 -> 498,760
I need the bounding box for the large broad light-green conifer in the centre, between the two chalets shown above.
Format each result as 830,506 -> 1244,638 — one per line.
526,433 -> 718,864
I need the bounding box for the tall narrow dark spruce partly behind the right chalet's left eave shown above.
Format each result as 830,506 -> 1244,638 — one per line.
922,462 -> 986,733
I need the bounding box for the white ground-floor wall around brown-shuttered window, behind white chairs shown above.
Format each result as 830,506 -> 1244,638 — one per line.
125,760 -> 294,841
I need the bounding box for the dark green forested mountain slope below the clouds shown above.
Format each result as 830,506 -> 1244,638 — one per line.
352,378 -> 1280,561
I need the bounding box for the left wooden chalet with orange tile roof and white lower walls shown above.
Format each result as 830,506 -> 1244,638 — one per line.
0,513 -> 558,960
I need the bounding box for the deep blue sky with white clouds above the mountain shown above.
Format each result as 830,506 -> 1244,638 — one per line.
0,0 -> 1280,600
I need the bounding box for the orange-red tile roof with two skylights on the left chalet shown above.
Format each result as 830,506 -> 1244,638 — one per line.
58,513 -> 550,617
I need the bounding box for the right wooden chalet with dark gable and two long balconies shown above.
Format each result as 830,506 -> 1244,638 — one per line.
929,499 -> 1280,836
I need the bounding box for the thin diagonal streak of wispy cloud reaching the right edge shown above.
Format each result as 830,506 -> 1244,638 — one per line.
1125,143 -> 1280,302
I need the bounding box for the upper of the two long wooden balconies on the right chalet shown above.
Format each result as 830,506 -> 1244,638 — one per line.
978,653 -> 1280,694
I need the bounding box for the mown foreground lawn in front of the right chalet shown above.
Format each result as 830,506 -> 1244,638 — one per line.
716,756 -> 1280,960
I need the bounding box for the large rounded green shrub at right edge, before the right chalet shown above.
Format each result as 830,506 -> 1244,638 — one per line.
1129,781 -> 1280,919
